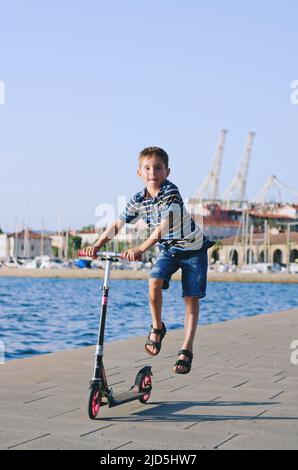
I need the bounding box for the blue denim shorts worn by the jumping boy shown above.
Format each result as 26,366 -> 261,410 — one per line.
149,247 -> 208,299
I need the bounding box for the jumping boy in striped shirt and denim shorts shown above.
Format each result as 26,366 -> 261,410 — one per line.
85,147 -> 214,374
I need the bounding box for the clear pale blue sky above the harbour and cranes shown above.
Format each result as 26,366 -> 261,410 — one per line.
0,0 -> 298,230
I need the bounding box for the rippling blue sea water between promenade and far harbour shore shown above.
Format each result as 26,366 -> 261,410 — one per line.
0,277 -> 298,361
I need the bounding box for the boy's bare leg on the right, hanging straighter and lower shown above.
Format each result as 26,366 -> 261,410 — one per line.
174,297 -> 199,372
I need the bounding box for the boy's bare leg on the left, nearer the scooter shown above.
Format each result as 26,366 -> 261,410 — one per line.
146,278 -> 163,355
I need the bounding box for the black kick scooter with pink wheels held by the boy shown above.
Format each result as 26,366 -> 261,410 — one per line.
78,250 -> 152,419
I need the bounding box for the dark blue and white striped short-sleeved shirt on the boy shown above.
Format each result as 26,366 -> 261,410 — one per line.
119,179 -> 213,251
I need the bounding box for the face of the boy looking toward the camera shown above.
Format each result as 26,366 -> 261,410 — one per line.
137,154 -> 170,192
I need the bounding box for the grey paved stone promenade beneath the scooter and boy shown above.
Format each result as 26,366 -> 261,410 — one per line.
0,306 -> 298,452
